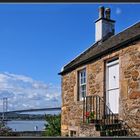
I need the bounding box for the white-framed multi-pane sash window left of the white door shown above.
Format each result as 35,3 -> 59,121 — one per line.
78,69 -> 86,101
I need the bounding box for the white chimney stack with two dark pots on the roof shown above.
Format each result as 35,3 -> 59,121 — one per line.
95,6 -> 115,42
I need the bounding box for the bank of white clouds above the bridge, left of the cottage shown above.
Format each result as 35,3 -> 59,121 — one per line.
0,72 -> 61,111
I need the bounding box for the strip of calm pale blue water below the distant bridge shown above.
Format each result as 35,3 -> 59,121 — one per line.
7,120 -> 46,131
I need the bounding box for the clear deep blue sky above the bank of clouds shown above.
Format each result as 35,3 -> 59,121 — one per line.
0,3 -> 140,110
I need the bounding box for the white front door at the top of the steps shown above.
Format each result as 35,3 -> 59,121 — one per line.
106,60 -> 119,114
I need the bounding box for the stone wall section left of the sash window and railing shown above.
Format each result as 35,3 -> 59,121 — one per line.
61,72 -> 83,136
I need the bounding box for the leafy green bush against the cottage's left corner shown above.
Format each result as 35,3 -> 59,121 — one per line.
43,114 -> 61,136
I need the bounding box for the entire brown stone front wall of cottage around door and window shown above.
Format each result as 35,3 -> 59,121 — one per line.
61,42 -> 140,136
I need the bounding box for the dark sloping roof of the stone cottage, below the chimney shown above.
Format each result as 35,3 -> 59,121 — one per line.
59,22 -> 140,75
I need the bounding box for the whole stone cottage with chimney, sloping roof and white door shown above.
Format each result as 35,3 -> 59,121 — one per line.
59,7 -> 140,136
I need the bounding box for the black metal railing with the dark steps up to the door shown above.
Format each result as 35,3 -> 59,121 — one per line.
83,95 -> 136,136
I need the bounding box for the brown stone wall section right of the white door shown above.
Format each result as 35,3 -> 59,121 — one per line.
120,43 -> 140,136
